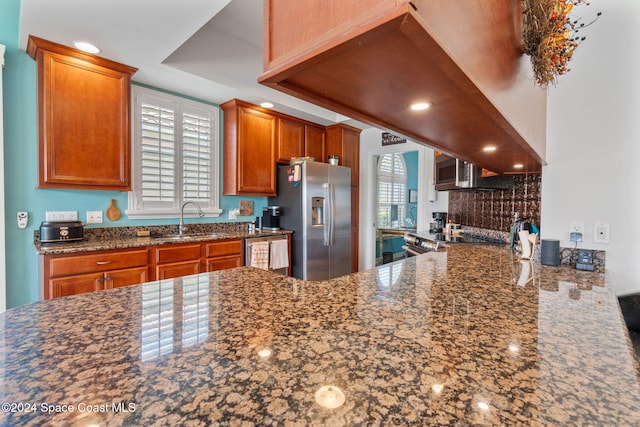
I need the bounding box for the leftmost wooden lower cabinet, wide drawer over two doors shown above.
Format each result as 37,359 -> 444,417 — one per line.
41,247 -> 150,299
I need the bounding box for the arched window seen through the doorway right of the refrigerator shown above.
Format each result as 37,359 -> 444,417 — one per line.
378,154 -> 407,227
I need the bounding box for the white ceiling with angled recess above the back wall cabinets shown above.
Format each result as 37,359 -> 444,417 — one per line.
20,0 -> 360,128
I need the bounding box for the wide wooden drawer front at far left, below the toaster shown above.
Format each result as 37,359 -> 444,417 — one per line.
49,248 -> 149,277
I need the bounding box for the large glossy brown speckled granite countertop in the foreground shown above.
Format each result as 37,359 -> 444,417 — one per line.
0,244 -> 640,426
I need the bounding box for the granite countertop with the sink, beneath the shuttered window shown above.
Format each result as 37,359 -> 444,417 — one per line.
34,223 -> 291,255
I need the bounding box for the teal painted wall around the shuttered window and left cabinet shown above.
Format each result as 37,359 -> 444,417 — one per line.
0,0 -> 267,308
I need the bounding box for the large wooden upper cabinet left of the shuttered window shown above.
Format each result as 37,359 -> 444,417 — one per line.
27,36 -> 137,191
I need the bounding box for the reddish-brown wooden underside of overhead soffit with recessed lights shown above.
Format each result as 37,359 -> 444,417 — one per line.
258,4 -> 542,173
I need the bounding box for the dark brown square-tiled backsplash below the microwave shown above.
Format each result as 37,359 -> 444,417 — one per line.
448,174 -> 542,232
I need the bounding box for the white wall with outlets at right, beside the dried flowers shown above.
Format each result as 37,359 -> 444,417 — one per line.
541,0 -> 640,295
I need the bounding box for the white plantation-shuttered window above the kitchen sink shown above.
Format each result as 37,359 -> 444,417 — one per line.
127,86 -> 221,218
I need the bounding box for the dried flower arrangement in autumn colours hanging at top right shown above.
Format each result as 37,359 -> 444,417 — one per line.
522,0 -> 601,89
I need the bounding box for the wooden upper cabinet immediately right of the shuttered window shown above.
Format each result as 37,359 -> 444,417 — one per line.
221,99 -> 278,196
